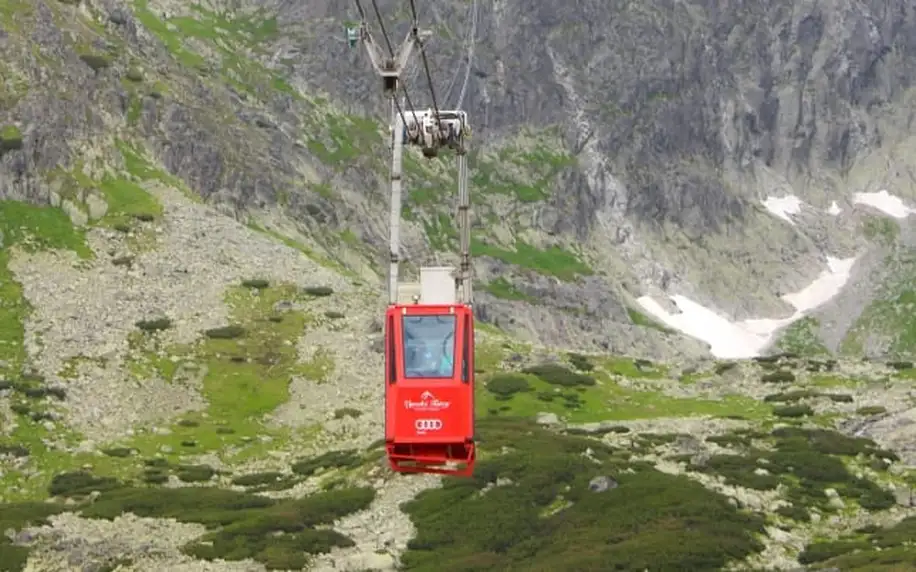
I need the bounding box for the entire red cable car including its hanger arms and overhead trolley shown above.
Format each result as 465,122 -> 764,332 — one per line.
357,1 -> 476,476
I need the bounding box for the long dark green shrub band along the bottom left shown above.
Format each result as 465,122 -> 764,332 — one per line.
0,472 -> 375,570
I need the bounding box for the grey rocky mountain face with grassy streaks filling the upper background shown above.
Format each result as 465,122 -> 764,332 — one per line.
0,0 -> 916,356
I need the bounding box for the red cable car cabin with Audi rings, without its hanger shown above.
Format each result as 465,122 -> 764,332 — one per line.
385,304 -> 476,476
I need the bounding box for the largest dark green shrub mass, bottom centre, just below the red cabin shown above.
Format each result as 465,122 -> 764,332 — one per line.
403,418 -> 763,571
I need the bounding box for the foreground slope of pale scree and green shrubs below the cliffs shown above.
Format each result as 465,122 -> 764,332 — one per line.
0,192 -> 914,570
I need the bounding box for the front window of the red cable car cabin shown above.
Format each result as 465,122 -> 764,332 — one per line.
403,315 -> 457,378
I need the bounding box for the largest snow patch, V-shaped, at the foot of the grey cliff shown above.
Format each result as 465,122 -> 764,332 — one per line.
636,256 -> 856,359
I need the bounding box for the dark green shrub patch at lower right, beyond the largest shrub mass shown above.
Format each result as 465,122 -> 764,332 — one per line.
689,427 -> 898,521
